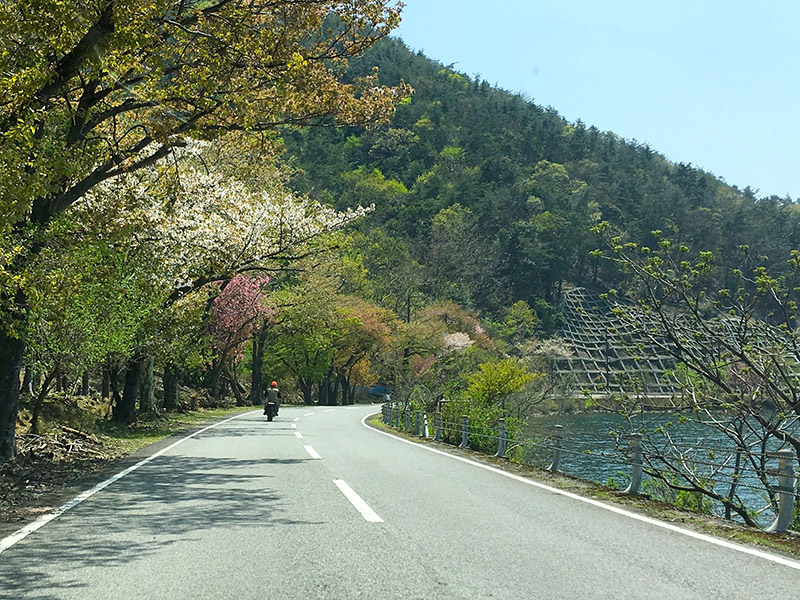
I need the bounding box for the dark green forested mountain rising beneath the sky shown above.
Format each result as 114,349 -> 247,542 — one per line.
285,34 -> 800,324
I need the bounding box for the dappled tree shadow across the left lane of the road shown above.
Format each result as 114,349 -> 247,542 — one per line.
0,456 -> 320,600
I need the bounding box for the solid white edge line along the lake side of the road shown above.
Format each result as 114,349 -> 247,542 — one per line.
361,413 -> 800,570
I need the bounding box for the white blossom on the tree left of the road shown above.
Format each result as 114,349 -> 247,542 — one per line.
76,142 -> 370,289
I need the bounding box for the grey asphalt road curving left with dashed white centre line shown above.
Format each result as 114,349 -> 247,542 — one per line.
0,406 -> 800,600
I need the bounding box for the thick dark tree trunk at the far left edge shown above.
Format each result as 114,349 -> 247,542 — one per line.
0,327 -> 25,462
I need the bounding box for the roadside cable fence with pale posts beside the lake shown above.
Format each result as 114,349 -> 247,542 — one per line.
381,402 -> 800,533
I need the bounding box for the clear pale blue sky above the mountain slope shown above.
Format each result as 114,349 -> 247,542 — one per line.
395,0 -> 800,200
